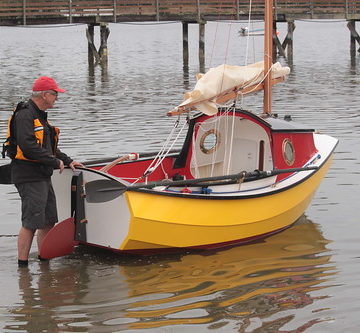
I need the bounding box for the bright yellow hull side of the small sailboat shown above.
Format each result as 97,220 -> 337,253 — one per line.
119,154 -> 331,251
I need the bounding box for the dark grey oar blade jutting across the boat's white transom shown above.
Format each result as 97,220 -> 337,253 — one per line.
85,179 -> 127,203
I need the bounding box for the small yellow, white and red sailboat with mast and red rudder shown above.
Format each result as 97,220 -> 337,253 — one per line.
40,1 -> 338,258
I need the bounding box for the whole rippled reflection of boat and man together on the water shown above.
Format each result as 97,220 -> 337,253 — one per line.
5,217 -> 335,332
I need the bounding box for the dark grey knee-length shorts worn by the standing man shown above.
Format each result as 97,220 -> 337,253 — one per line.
15,180 -> 58,230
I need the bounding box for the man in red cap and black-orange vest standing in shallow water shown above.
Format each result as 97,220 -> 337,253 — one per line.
9,76 -> 83,266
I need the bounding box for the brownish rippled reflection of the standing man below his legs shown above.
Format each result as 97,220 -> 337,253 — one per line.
4,262 -> 88,333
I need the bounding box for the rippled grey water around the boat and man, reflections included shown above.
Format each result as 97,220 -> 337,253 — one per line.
0,22 -> 360,333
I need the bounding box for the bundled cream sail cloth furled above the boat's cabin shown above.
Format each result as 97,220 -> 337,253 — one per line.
179,61 -> 290,115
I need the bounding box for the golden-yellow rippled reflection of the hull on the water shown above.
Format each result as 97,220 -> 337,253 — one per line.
122,215 -> 334,328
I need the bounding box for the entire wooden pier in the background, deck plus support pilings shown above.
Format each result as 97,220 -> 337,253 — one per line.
0,0 -> 360,71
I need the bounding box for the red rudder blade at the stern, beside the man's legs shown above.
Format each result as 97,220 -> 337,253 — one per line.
40,217 -> 77,259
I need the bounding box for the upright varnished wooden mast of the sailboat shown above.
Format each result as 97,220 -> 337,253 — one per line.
263,0 -> 273,115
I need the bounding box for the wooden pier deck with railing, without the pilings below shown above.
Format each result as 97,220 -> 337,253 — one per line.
0,0 -> 360,25
